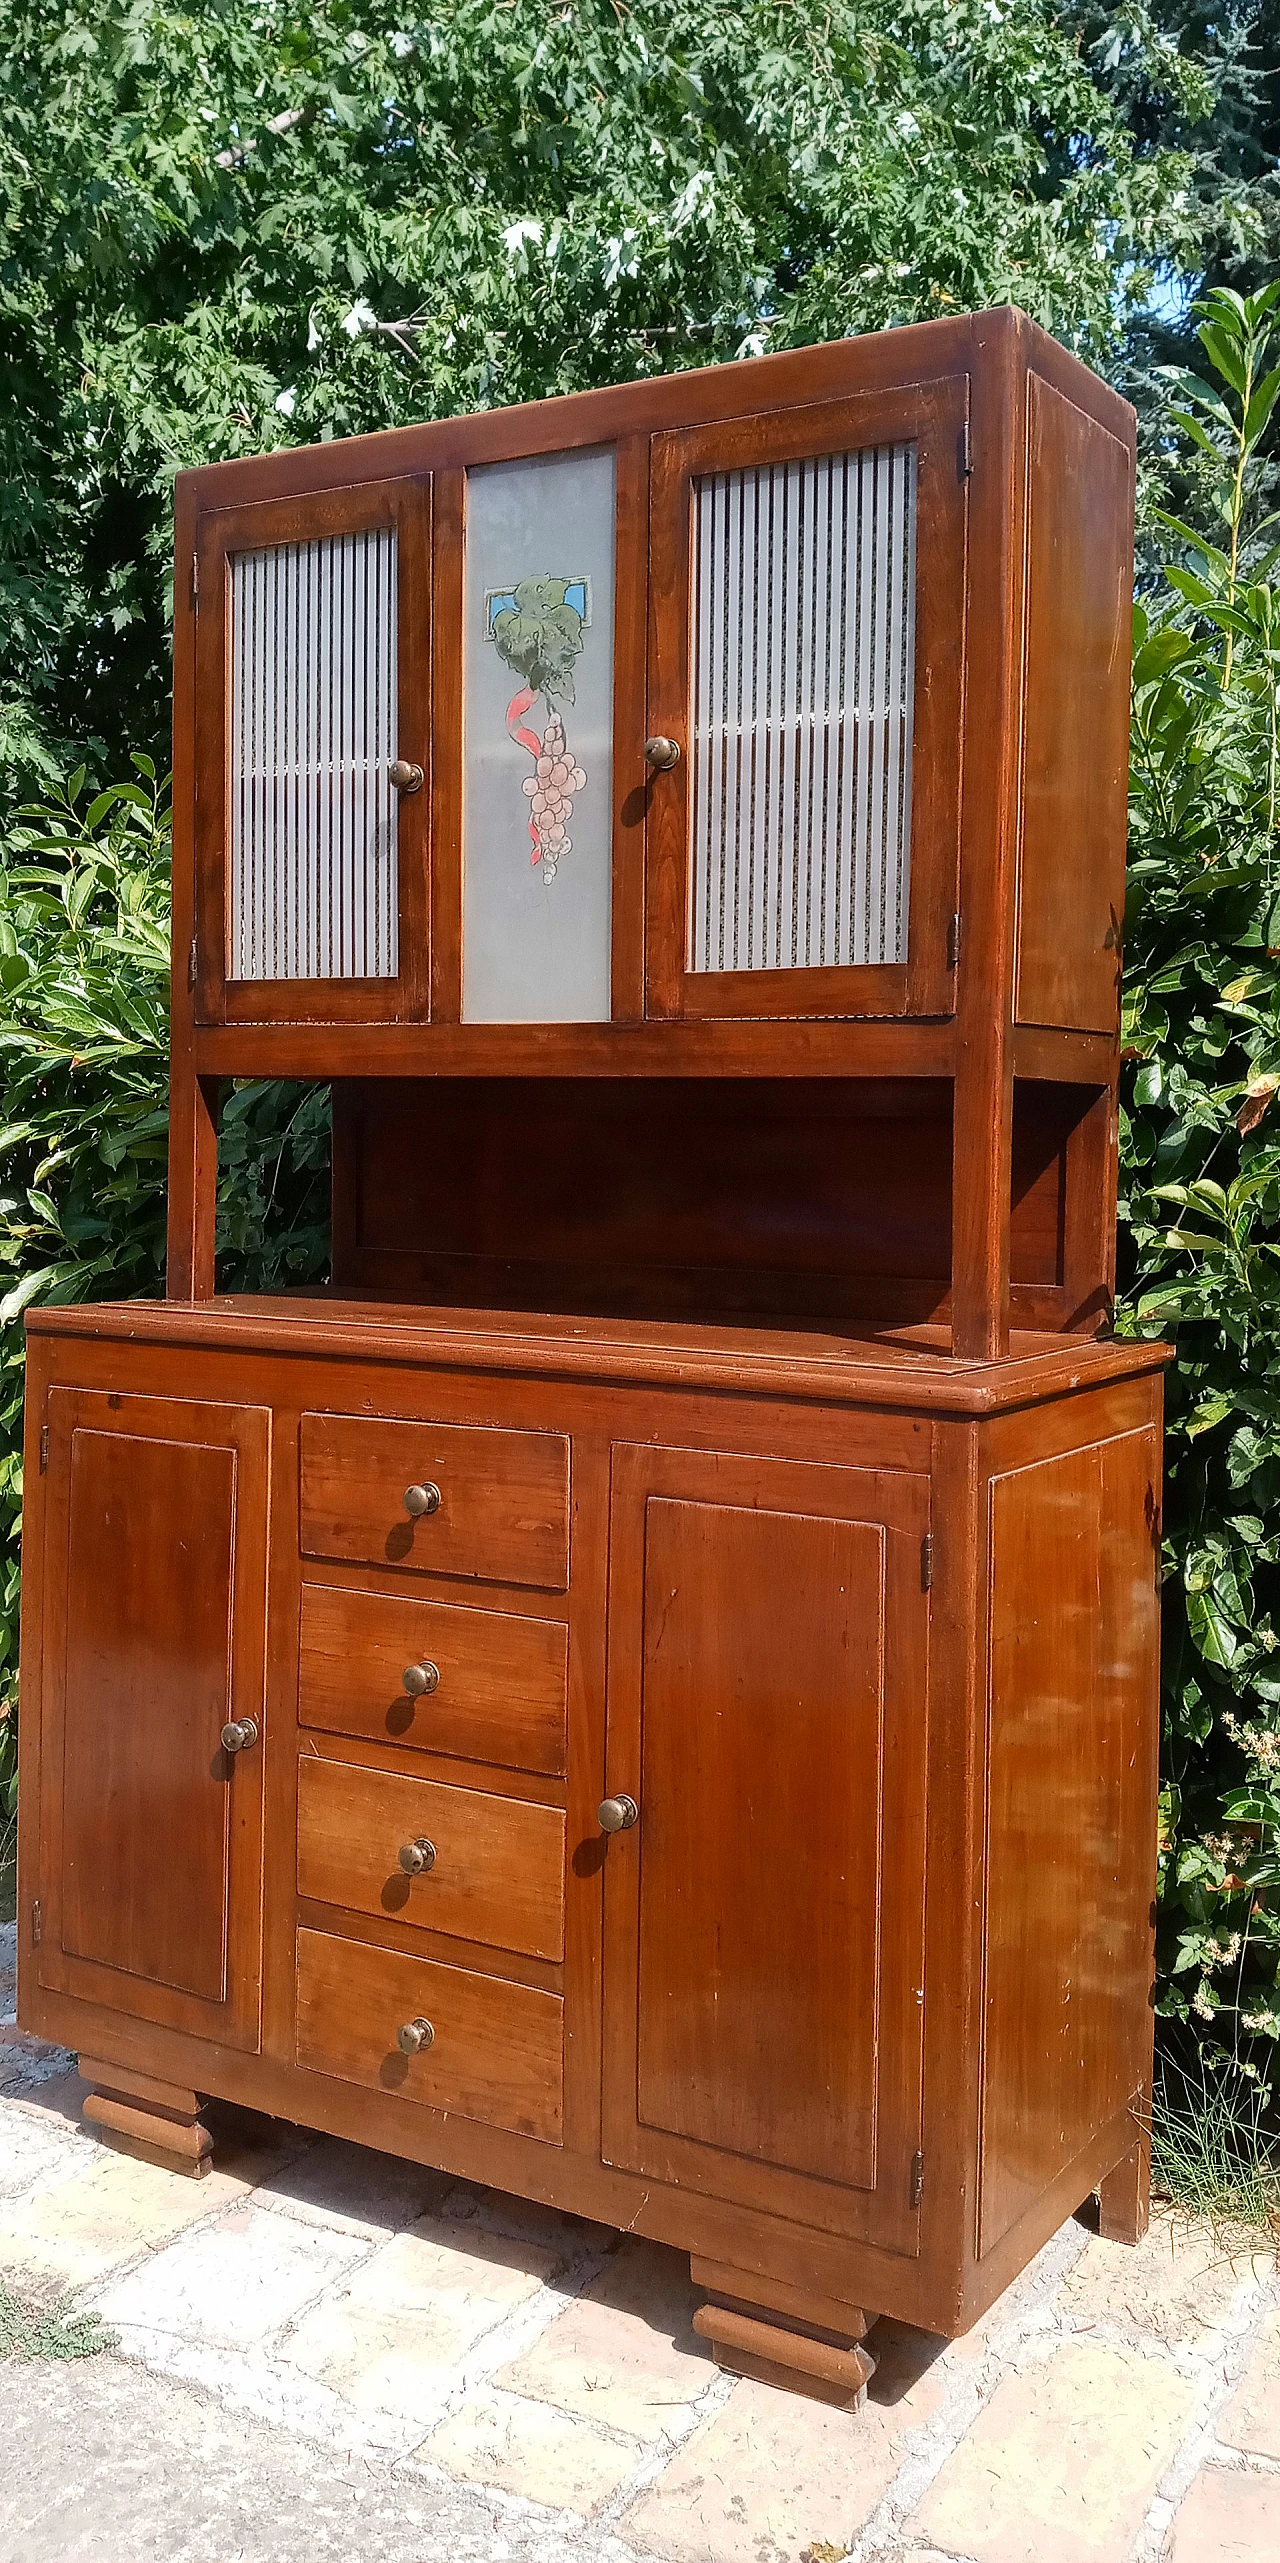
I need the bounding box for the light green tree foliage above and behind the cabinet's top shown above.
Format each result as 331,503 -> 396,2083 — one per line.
0,0 -> 1203,777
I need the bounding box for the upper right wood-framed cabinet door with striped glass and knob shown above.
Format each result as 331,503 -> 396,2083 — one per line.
649,382 -> 967,1018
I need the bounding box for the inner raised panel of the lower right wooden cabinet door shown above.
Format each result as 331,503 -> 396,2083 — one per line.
636,1497 -> 885,2189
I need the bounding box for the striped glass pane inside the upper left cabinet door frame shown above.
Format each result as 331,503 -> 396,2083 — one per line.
228,528 -> 400,979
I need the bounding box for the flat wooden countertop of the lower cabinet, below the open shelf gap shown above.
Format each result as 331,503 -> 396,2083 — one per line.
26,1292 -> 1172,1415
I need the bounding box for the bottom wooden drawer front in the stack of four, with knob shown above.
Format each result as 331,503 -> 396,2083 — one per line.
295,1930 -> 564,2145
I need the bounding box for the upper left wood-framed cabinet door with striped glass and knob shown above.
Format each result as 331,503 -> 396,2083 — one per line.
195,479 -> 431,1023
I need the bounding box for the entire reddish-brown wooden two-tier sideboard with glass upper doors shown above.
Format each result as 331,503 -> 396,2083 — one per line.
18,310 -> 1165,2407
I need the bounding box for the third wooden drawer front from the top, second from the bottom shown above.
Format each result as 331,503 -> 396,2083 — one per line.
298,1753 -> 564,1961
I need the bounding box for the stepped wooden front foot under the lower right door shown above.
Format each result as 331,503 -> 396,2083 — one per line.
690,2258 -> 875,2412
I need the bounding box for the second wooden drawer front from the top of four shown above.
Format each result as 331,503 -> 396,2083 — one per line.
298,1584 -> 569,1779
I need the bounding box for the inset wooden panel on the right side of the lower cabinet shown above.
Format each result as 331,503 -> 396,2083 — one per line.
980,1433 -> 1159,2253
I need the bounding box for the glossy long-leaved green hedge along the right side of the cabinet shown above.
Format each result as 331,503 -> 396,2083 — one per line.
1121,282 -> 1280,2076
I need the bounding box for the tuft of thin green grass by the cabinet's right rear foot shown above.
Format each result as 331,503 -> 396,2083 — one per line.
1152,2040 -> 1280,2248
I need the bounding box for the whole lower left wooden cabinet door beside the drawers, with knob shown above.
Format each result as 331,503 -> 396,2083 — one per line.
41,1389 -> 269,2045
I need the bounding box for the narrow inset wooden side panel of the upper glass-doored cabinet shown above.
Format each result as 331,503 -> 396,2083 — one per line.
1016,374 -> 1134,1033
